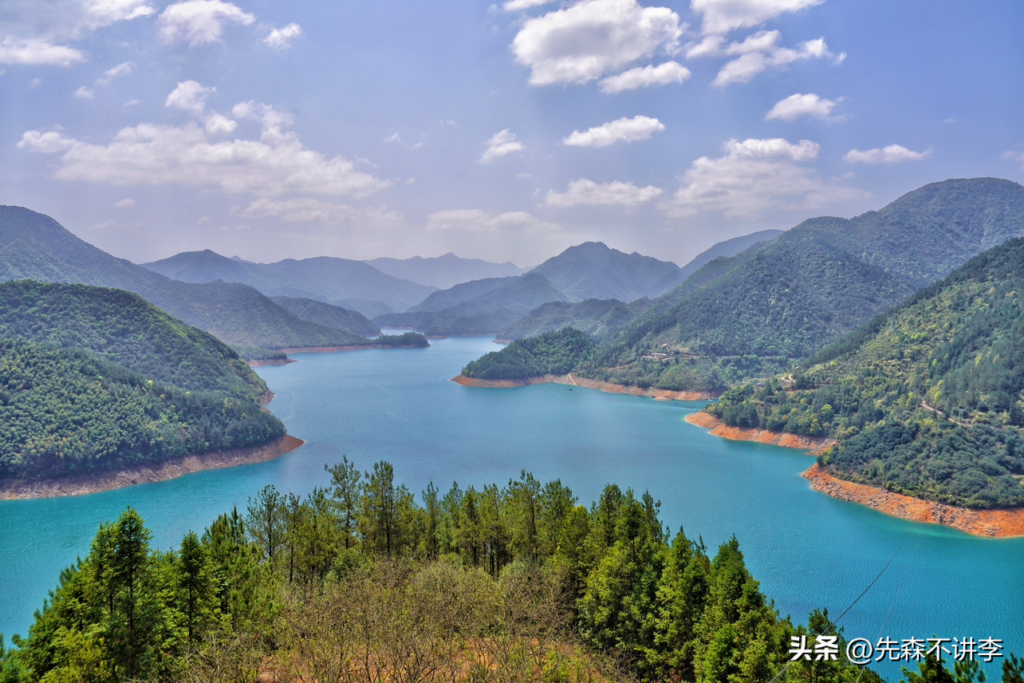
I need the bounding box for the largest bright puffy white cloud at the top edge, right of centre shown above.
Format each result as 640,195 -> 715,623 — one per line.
512,0 -> 685,85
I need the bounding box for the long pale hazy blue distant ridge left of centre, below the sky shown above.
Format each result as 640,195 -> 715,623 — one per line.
143,250 -> 435,310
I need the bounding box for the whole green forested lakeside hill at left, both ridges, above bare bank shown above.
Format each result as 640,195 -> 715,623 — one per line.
0,281 -> 285,479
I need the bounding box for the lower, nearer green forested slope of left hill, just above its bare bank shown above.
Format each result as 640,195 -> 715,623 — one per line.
0,338 -> 285,478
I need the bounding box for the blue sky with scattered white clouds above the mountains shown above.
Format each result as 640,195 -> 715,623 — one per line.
0,0 -> 1024,266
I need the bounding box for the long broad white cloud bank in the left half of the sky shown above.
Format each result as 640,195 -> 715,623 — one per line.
18,89 -> 391,197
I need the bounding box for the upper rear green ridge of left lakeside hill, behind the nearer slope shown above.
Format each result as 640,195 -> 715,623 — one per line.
0,281 -> 266,399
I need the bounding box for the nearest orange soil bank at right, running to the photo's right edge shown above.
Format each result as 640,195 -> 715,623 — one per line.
804,464 -> 1024,539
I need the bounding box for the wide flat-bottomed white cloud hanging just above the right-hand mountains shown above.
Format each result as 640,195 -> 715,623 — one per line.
666,138 -> 866,218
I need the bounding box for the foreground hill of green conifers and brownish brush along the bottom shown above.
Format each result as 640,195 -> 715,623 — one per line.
0,466 -> 905,683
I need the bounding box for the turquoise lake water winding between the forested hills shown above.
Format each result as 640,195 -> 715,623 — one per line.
0,339 -> 1024,675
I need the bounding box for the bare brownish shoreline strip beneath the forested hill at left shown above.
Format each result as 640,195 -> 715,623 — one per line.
0,434 -> 305,501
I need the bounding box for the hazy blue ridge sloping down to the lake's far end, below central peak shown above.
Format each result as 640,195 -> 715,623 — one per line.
374,272 -> 567,337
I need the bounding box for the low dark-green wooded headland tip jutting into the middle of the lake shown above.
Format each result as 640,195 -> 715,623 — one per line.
462,328 -> 594,380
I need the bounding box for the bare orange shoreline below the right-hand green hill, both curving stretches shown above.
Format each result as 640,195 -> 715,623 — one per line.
686,411 -> 1024,539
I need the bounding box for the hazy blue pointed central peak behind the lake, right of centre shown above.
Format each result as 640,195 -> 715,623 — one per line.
531,242 -> 682,302
